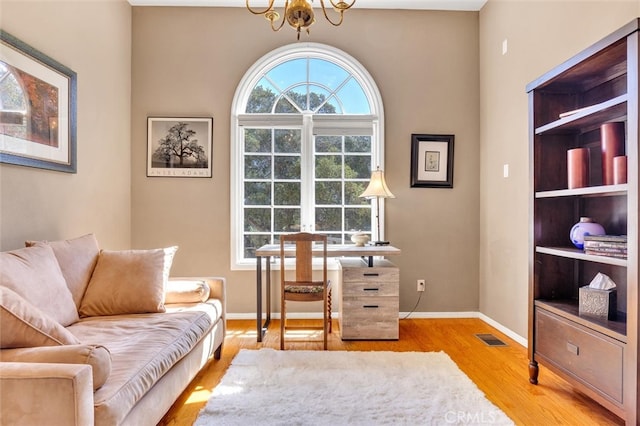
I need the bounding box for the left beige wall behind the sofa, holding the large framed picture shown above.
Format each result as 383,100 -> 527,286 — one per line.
0,0 -> 131,250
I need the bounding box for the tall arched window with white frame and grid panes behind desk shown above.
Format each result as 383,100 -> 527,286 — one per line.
231,43 -> 383,268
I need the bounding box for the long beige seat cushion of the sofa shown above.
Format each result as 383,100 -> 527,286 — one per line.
69,303 -> 220,424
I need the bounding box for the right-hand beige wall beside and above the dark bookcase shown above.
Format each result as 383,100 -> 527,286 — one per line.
480,0 -> 640,336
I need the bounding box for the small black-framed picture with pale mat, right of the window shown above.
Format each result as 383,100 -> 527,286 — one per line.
411,134 -> 454,188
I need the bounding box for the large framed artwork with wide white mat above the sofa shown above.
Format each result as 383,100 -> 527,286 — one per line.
0,30 -> 77,173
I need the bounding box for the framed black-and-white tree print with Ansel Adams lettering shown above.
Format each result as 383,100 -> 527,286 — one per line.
147,117 -> 213,177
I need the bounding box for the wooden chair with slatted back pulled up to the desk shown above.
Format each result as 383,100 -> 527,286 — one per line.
280,232 -> 332,350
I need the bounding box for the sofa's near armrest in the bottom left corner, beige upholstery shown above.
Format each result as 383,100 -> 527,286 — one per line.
0,362 -> 94,425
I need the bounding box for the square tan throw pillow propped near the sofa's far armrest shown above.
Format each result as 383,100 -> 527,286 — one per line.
80,247 -> 178,317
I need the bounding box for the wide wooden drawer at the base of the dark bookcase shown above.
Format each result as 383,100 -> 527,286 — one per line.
535,308 -> 624,403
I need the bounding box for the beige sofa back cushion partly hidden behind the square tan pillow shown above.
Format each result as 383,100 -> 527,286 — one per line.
25,234 -> 100,309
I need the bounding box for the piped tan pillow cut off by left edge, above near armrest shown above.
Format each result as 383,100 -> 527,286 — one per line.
0,287 -> 80,349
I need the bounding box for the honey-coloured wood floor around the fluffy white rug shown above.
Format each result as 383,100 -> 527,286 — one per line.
160,319 -> 624,426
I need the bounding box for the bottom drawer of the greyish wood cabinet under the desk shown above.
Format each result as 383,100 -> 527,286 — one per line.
340,297 -> 399,340
